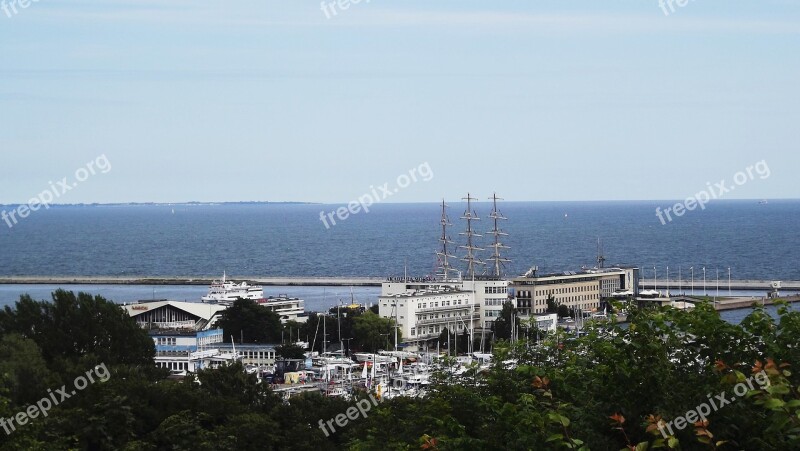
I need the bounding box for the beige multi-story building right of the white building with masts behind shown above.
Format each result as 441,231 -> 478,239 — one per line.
509,267 -> 639,316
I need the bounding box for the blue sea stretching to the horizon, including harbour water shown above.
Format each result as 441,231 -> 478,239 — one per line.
0,200 -> 800,309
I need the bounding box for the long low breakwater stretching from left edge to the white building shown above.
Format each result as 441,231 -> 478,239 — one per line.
0,275 -> 386,287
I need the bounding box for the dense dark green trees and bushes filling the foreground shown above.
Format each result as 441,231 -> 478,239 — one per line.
0,291 -> 800,450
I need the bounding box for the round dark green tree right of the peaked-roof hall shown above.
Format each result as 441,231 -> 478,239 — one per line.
217,299 -> 282,343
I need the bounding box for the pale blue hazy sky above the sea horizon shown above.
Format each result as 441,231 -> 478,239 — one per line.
0,0 -> 800,204
